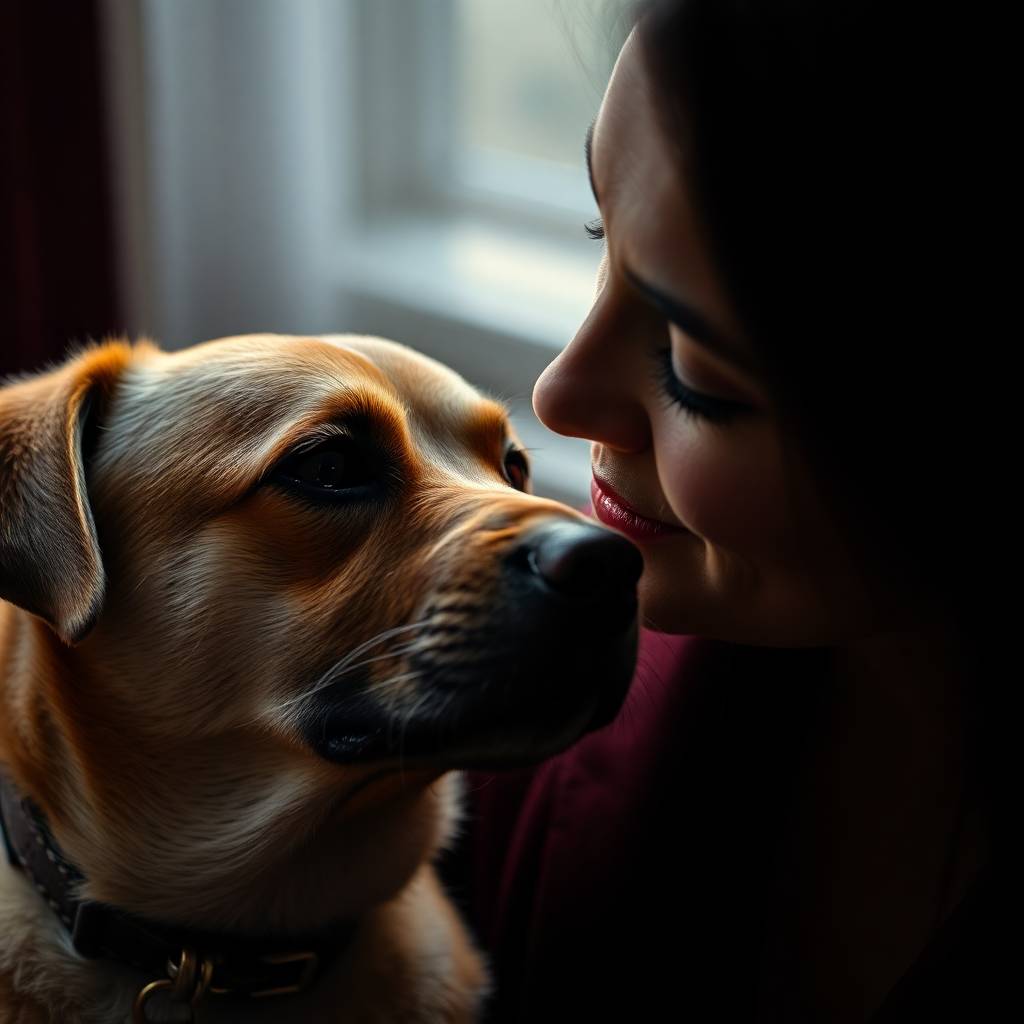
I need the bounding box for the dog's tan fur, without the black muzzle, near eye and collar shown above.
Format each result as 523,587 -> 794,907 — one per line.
0,336 -> 598,1024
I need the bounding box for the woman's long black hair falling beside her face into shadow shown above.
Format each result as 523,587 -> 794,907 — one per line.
638,0 -> 1003,806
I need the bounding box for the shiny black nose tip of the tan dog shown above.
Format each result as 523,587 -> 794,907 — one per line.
526,522 -> 643,598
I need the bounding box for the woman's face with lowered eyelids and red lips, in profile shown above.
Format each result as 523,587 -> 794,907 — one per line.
534,33 -> 880,645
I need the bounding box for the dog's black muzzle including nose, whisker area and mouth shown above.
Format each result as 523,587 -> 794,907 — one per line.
309,519 -> 643,768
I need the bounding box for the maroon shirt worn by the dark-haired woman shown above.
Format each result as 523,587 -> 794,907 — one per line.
456,632 -> 993,1024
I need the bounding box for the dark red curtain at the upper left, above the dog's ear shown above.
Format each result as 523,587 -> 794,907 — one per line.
0,0 -> 120,376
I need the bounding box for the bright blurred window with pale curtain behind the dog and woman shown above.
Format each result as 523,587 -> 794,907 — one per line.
106,0 -> 629,504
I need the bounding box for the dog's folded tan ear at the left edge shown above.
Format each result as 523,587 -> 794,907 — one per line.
0,342 -> 132,643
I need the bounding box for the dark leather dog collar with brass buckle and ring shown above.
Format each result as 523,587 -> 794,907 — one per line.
0,773 -> 356,1021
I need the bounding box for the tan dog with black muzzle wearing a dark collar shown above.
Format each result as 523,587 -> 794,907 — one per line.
0,335 -> 642,1024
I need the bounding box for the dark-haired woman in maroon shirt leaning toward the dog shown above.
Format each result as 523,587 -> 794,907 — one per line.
458,0 -> 1009,1021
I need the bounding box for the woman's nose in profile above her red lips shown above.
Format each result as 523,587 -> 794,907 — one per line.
534,296 -> 650,452
